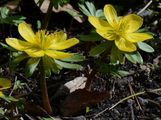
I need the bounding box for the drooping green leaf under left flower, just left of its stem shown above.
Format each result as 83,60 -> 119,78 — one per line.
25,58 -> 40,77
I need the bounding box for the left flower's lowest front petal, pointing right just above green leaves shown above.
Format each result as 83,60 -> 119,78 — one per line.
45,50 -> 72,59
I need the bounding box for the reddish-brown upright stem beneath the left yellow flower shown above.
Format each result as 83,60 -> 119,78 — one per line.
39,60 -> 52,114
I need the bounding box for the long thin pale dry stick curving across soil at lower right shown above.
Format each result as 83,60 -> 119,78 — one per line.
94,88 -> 161,118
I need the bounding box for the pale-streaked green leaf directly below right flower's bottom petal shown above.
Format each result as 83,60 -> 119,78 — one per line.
125,52 -> 143,64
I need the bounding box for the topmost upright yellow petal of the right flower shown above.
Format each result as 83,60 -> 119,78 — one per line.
104,4 -> 118,28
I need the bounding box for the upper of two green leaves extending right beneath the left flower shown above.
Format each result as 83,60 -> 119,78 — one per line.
61,54 -> 85,62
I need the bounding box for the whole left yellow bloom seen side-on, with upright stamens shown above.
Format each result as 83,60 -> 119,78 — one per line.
6,22 -> 79,59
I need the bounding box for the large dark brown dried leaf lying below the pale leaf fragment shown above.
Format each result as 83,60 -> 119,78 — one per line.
60,89 -> 110,116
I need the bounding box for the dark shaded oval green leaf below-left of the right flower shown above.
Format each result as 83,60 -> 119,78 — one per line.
89,42 -> 109,56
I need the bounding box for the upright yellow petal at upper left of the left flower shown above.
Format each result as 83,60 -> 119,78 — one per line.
18,22 -> 36,44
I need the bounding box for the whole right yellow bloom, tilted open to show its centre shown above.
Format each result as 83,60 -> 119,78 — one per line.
88,4 -> 153,52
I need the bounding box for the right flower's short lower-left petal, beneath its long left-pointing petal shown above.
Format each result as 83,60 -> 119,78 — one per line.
96,29 -> 117,40
